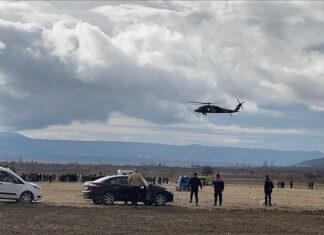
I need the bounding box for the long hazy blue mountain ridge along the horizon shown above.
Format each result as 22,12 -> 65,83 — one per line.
0,133 -> 324,166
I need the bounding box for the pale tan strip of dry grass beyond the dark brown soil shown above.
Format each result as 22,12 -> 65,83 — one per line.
40,182 -> 324,210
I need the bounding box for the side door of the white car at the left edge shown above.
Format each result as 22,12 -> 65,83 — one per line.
0,171 -> 23,199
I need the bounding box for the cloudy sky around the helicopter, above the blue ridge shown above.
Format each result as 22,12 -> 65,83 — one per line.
0,1 -> 324,152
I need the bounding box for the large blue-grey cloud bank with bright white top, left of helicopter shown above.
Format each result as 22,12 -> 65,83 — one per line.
0,2 -> 199,129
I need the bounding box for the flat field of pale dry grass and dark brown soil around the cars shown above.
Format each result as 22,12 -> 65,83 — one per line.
0,183 -> 324,234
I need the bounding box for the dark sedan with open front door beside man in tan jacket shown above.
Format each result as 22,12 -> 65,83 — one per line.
82,175 -> 173,206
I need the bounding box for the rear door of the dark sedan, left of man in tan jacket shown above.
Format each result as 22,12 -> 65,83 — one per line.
110,177 -> 132,201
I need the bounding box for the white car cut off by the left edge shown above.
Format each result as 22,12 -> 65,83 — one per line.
0,167 -> 42,203
